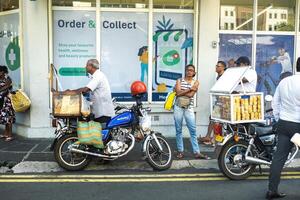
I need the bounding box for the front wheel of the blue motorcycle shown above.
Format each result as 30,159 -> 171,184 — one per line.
146,135 -> 173,171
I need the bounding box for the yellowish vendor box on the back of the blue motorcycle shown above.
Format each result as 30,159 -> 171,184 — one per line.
52,92 -> 90,117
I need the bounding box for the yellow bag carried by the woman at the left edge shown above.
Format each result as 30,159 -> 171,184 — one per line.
9,90 -> 31,112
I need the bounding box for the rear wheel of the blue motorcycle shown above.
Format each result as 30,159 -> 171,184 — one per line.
54,134 -> 90,171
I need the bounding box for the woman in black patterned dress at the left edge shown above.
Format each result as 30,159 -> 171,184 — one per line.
0,66 -> 16,142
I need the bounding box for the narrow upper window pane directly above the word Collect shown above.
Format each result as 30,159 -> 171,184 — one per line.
100,0 -> 149,8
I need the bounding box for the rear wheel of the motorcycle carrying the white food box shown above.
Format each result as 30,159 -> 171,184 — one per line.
218,140 -> 256,180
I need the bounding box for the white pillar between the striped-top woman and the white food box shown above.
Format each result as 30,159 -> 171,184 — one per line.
196,0 -> 220,135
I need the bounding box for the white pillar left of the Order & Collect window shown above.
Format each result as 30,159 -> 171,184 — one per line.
14,0 -> 53,137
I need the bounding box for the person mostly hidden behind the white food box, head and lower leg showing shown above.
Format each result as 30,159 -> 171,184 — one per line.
198,61 -> 226,144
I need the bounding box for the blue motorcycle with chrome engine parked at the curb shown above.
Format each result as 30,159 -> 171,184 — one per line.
52,95 -> 172,171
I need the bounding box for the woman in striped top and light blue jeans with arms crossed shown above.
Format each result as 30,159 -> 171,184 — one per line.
174,64 -> 209,159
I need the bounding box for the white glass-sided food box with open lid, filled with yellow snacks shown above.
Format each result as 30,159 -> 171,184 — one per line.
210,66 -> 264,124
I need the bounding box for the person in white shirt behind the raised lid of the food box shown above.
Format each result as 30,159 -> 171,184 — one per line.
234,56 -> 257,93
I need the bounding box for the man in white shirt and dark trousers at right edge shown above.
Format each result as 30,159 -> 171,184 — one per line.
266,57 -> 300,199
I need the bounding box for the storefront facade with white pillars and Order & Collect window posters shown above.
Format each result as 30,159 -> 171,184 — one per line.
0,0 -> 300,138
